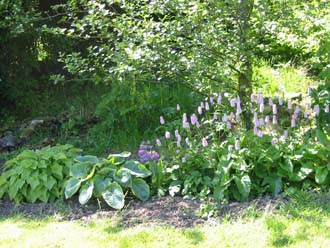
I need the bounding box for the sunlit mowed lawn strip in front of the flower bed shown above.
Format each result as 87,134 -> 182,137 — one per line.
0,193 -> 330,248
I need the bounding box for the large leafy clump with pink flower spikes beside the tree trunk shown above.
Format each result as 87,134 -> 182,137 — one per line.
154,89 -> 330,203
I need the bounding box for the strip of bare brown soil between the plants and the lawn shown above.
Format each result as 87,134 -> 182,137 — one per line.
0,196 -> 287,227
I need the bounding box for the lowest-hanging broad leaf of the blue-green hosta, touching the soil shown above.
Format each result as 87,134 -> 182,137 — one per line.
102,182 -> 125,209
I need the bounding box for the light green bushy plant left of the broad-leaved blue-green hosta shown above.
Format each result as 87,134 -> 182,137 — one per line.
0,145 -> 81,202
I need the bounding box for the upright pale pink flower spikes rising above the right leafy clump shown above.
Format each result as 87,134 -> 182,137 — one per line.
156,88 -> 329,161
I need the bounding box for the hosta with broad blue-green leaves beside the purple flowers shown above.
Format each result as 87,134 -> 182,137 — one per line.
65,152 -> 151,209
